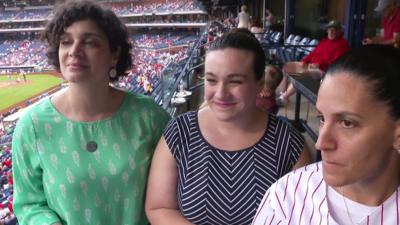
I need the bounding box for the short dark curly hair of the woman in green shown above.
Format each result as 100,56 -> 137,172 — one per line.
42,0 -> 132,81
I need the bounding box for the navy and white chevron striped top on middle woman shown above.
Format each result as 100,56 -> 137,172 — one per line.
164,111 -> 304,225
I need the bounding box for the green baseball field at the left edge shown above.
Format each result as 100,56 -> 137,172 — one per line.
0,74 -> 62,111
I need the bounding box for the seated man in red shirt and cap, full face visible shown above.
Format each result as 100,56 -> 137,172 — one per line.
279,20 -> 350,104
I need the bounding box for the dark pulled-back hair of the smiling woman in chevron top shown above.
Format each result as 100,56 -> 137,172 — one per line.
208,28 -> 265,80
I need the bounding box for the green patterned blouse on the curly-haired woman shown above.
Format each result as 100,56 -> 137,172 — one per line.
12,93 -> 170,225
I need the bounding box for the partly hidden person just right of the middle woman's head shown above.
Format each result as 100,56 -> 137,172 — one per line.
256,66 -> 283,113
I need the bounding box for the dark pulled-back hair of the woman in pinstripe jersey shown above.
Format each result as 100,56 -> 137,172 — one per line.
326,45 -> 400,120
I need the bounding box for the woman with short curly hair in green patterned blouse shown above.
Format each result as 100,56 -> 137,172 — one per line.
12,0 -> 170,225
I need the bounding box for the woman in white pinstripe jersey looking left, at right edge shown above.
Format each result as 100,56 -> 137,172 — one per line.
254,45 -> 400,225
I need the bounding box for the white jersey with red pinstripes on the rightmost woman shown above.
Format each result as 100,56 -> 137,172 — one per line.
253,162 -> 400,225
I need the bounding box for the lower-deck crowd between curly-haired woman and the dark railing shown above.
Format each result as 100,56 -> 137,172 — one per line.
114,32 -> 196,94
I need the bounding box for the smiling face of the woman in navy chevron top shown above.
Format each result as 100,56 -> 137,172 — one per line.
204,48 -> 263,123
